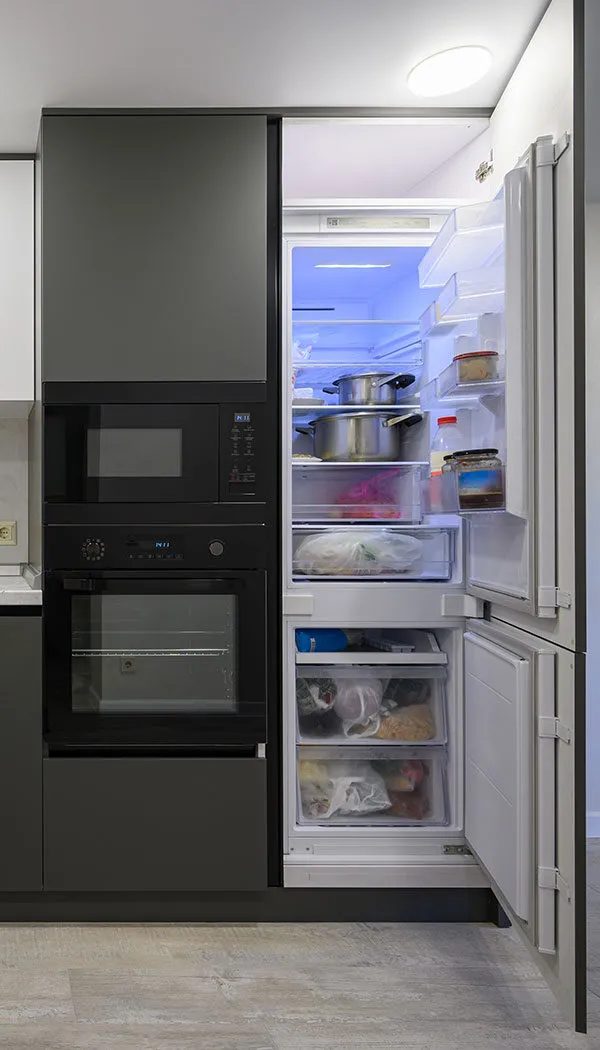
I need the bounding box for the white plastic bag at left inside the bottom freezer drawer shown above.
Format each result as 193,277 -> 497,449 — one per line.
298,760 -> 391,820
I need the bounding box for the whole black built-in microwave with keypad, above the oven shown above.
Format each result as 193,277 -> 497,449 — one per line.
43,382 -> 276,512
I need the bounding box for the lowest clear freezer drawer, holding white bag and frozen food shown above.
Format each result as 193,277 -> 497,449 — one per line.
297,746 -> 449,827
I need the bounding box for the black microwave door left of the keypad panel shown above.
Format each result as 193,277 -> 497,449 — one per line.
44,404 -> 220,503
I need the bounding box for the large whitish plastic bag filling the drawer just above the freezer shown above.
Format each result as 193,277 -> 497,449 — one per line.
294,528 -> 422,576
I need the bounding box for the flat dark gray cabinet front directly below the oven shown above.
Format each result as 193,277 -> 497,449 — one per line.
44,757 -> 267,893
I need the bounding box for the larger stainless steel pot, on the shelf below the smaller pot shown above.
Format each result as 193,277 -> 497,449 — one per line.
296,412 -> 422,463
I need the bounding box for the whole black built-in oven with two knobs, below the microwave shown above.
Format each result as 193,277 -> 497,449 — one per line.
43,525 -> 269,752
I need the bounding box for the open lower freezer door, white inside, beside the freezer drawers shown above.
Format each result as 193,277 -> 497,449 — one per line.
464,621 -> 586,1024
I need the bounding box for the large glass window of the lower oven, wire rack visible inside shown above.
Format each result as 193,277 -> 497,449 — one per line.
71,594 -> 237,715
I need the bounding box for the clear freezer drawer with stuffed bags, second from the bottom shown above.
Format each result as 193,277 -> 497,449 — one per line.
296,664 -> 448,748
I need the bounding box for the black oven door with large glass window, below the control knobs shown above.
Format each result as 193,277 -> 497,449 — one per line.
43,571 -> 267,750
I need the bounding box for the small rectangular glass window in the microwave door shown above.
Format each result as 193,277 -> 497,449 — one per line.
87,426 -> 182,478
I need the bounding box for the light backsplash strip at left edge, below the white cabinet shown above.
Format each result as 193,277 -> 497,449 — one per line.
0,419 -> 28,566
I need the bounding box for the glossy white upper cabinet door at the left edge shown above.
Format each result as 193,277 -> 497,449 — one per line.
0,161 -> 34,415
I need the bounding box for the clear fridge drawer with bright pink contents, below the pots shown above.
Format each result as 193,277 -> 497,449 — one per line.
292,463 -> 423,525
